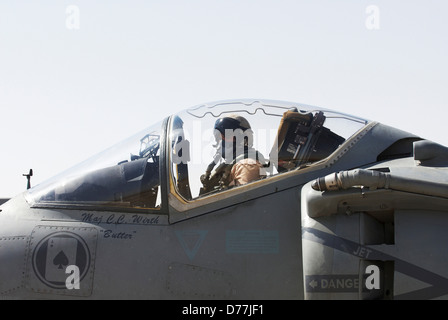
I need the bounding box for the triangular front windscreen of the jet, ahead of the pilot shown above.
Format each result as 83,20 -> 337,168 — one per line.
27,122 -> 162,209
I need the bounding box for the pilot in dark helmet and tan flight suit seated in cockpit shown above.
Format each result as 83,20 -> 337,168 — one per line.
207,115 -> 266,186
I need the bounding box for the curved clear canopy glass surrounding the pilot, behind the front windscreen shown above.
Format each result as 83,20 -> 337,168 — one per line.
169,100 -> 368,200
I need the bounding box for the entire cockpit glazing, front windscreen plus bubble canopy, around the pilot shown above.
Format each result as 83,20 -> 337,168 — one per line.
26,100 -> 367,210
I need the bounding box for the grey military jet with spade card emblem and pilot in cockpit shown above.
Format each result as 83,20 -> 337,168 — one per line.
0,100 -> 448,300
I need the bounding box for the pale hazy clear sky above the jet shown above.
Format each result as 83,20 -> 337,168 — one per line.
0,0 -> 448,197
